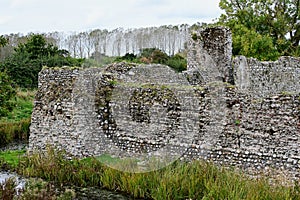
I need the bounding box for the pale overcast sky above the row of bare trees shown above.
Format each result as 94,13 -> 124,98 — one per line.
0,0 -> 221,35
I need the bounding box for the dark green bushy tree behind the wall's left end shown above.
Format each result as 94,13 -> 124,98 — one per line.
0,35 -> 83,88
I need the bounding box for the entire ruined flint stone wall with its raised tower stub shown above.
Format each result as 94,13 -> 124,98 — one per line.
29,27 -> 300,179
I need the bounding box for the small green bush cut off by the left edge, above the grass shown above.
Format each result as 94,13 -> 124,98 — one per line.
0,72 -> 16,117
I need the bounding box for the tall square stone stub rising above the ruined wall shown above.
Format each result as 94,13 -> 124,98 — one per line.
187,27 -> 234,84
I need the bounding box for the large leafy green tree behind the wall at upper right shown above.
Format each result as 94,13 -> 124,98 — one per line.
219,0 -> 300,60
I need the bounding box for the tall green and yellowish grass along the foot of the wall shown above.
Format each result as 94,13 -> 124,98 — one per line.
0,148 -> 300,200
